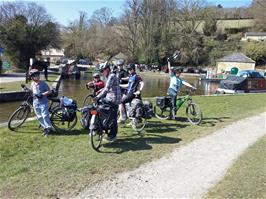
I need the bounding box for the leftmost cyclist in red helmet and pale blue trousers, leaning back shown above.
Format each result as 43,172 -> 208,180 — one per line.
29,69 -> 52,136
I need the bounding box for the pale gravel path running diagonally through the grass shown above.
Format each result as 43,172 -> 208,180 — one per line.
77,112 -> 266,198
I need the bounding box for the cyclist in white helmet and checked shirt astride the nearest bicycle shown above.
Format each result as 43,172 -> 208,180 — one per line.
94,61 -> 121,142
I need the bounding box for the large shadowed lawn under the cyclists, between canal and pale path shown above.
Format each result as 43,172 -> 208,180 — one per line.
0,94 -> 266,198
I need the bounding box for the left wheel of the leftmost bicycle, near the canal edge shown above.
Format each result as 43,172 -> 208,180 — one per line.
8,106 -> 30,131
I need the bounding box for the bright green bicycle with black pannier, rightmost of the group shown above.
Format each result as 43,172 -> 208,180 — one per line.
154,90 -> 202,125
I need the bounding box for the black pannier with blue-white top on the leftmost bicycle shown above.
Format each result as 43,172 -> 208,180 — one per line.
60,97 -> 77,122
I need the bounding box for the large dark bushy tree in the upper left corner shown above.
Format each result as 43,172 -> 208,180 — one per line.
0,2 -> 60,69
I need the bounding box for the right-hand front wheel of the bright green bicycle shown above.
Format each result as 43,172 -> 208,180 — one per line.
186,103 -> 202,125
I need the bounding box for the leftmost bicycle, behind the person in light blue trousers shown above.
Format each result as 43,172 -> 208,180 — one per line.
8,84 -> 77,132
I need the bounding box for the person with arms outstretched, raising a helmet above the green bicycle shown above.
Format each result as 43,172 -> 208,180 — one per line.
167,59 -> 196,119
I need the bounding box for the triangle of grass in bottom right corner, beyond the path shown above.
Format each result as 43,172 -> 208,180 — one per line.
205,136 -> 266,199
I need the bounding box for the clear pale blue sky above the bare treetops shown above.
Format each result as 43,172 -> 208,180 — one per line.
0,0 -> 252,26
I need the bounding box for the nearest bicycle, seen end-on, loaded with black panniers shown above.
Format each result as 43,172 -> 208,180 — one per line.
86,102 -> 116,151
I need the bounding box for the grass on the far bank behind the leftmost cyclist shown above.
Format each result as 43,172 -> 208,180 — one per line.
0,74 -> 58,92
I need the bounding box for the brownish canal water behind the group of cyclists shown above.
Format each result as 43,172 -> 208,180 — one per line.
0,72 -> 219,123
